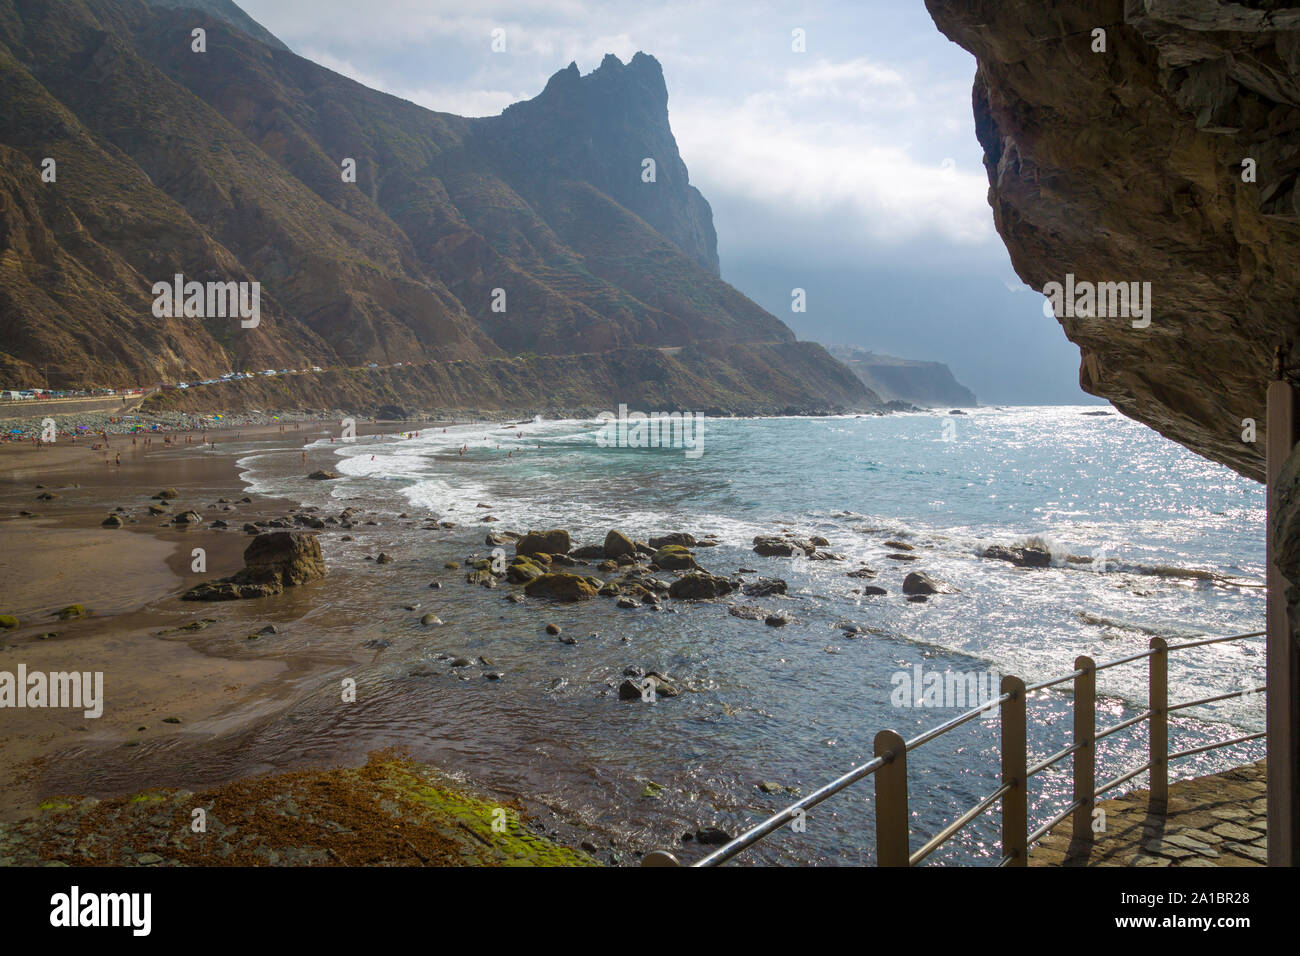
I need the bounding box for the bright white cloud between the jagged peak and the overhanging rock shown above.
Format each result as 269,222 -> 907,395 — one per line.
672,60 -> 996,245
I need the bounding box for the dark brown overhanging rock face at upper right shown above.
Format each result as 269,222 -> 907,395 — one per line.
926,0 -> 1300,480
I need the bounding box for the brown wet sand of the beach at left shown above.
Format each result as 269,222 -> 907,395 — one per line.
0,423 -> 447,819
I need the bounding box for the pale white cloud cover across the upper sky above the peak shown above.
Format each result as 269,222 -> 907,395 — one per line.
246,0 -> 996,246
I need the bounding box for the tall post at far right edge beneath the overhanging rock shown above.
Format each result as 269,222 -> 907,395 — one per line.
1265,376 -> 1300,866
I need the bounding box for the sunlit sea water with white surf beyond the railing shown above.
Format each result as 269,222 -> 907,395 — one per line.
242,407 -> 1264,864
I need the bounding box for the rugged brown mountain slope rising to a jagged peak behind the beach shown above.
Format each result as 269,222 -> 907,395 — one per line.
0,0 -> 876,410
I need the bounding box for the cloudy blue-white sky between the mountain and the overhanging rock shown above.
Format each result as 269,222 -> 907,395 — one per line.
239,0 -> 1096,405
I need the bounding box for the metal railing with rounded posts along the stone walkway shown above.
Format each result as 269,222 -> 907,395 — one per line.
641,631 -> 1265,866
